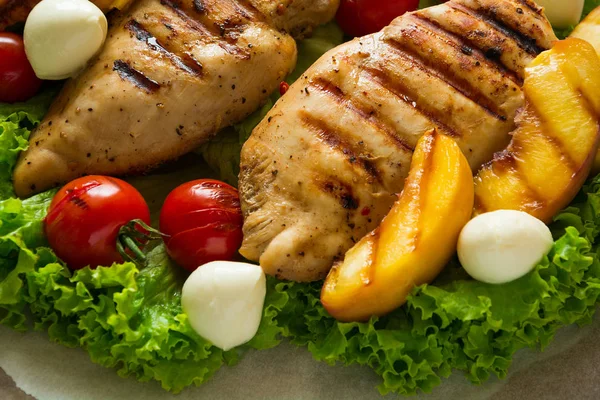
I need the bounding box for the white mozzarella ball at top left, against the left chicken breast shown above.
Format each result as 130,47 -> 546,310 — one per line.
23,0 -> 108,80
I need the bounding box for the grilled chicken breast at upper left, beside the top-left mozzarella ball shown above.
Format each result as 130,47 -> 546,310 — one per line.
13,0 -> 338,196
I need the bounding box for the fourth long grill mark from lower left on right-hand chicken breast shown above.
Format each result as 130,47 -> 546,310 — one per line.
384,36 -> 506,121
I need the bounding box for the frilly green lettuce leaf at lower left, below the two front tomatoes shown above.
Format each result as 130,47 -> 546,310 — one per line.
0,203 -> 283,392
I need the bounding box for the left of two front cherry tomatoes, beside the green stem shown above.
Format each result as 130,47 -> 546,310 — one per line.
44,176 -> 150,269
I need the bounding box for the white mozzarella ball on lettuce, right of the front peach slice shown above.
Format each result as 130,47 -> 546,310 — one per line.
458,210 -> 554,284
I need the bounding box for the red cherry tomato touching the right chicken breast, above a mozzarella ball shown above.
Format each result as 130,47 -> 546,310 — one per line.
160,179 -> 243,271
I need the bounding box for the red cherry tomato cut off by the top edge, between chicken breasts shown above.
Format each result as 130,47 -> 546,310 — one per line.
336,0 -> 419,36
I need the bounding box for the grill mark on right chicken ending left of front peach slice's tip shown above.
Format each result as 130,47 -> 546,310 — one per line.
310,77 -> 415,153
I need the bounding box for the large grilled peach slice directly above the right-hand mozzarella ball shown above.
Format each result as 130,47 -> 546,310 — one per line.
475,38 -> 600,222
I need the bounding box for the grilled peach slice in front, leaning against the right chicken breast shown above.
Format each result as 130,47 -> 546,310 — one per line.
321,131 -> 474,321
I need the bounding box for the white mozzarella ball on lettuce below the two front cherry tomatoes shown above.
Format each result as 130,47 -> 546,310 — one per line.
181,261 -> 267,350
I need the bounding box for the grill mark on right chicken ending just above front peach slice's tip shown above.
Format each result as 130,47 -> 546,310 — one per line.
363,68 -> 462,137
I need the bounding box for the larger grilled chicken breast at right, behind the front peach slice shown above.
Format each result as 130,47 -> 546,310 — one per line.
240,0 -> 556,281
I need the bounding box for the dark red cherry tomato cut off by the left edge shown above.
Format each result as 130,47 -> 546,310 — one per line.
0,32 -> 42,103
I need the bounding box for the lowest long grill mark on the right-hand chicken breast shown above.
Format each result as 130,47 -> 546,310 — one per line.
300,111 -> 382,183
